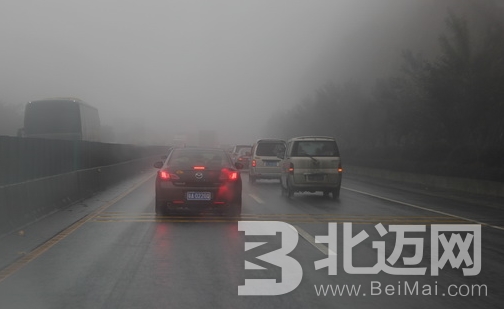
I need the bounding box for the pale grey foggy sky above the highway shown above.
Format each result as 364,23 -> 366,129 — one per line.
0,0 -> 456,143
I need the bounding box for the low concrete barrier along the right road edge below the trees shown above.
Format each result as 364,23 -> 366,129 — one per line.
344,165 -> 504,197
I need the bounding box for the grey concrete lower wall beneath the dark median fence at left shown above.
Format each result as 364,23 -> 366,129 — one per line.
0,155 -> 161,236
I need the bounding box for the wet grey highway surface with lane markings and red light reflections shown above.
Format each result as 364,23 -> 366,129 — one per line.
0,173 -> 504,308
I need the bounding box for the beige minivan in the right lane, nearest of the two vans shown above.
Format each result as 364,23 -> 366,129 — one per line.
279,136 -> 343,199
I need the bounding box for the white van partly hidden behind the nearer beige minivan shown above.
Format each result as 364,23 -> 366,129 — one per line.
249,138 -> 285,183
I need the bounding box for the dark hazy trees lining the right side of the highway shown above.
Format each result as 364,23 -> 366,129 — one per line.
267,13 -> 504,181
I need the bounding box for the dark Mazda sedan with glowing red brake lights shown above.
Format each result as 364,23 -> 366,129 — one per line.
154,148 -> 243,216
